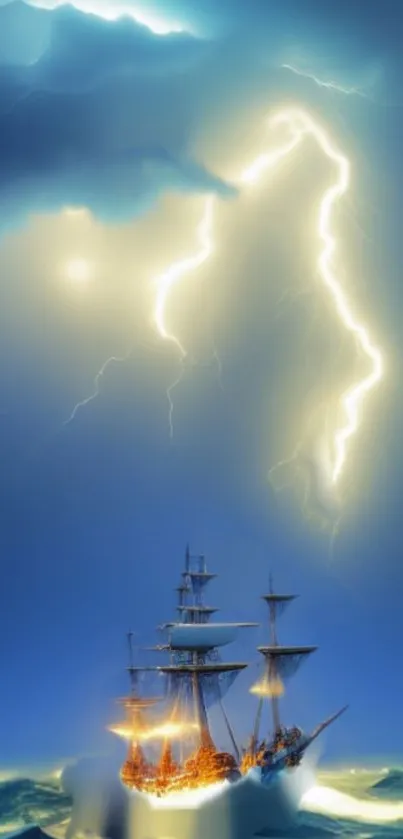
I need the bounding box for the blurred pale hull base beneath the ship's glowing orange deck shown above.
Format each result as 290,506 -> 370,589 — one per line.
63,757 -> 314,839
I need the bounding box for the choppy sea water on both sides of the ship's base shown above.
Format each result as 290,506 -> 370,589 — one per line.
0,767 -> 403,839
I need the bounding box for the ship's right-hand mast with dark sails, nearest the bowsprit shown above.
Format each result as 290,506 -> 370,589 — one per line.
253,575 -> 317,743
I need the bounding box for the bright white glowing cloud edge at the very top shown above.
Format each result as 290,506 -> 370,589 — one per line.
25,0 -> 189,36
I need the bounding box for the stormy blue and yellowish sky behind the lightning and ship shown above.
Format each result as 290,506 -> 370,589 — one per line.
0,0 -> 403,766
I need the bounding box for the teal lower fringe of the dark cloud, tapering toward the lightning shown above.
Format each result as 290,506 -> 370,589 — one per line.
0,139 -> 235,232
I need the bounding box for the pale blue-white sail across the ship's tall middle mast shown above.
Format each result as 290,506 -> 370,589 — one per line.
169,623 -> 256,651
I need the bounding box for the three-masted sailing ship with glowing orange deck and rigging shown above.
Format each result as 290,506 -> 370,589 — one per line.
110,548 -> 345,796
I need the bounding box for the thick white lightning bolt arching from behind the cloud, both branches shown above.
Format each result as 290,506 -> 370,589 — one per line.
154,108 -> 383,496
